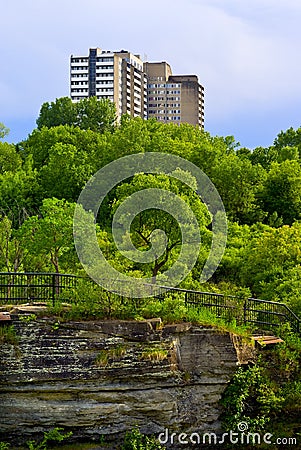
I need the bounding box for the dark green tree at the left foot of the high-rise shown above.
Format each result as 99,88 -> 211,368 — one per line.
37,97 -> 116,133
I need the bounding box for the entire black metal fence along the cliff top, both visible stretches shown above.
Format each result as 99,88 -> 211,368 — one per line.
0,272 -> 301,333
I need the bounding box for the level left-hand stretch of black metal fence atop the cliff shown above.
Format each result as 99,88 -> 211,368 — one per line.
0,272 -> 78,305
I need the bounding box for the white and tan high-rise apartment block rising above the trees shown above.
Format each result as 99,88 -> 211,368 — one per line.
70,48 -> 204,127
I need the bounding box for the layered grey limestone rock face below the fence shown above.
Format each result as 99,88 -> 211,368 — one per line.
0,315 -> 238,448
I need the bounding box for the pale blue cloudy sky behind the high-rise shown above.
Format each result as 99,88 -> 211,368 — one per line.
0,0 -> 301,148
